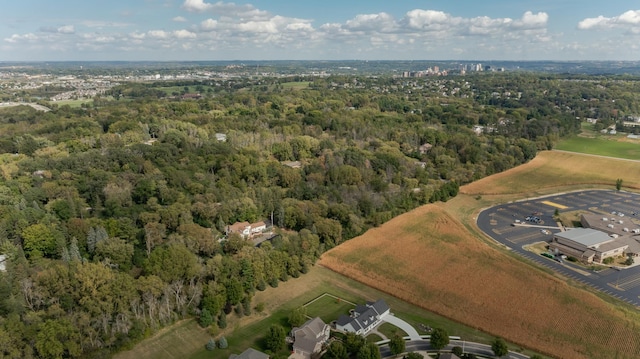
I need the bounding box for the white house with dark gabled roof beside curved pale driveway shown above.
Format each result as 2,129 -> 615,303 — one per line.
336,299 -> 389,335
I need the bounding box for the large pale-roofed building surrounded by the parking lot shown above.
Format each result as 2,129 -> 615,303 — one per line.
549,228 -> 629,263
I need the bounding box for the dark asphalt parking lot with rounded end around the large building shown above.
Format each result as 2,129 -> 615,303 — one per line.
477,190 -> 640,308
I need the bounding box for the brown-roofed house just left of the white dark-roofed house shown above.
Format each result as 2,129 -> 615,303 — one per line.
289,317 -> 331,359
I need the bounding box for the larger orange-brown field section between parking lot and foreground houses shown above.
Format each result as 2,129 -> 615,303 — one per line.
319,201 -> 640,358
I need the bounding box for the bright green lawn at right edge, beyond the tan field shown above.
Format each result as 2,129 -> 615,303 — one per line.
556,136 -> 640,160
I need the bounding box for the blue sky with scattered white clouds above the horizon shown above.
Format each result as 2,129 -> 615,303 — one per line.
0,0 -> 640,61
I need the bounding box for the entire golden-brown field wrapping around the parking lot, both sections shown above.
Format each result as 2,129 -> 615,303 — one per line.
319,152 -> 640,358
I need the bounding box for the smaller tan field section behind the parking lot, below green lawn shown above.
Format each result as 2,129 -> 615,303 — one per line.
460,151 -> 640,195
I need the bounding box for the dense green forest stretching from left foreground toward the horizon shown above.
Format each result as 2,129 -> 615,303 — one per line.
0,74 -> 640,358
